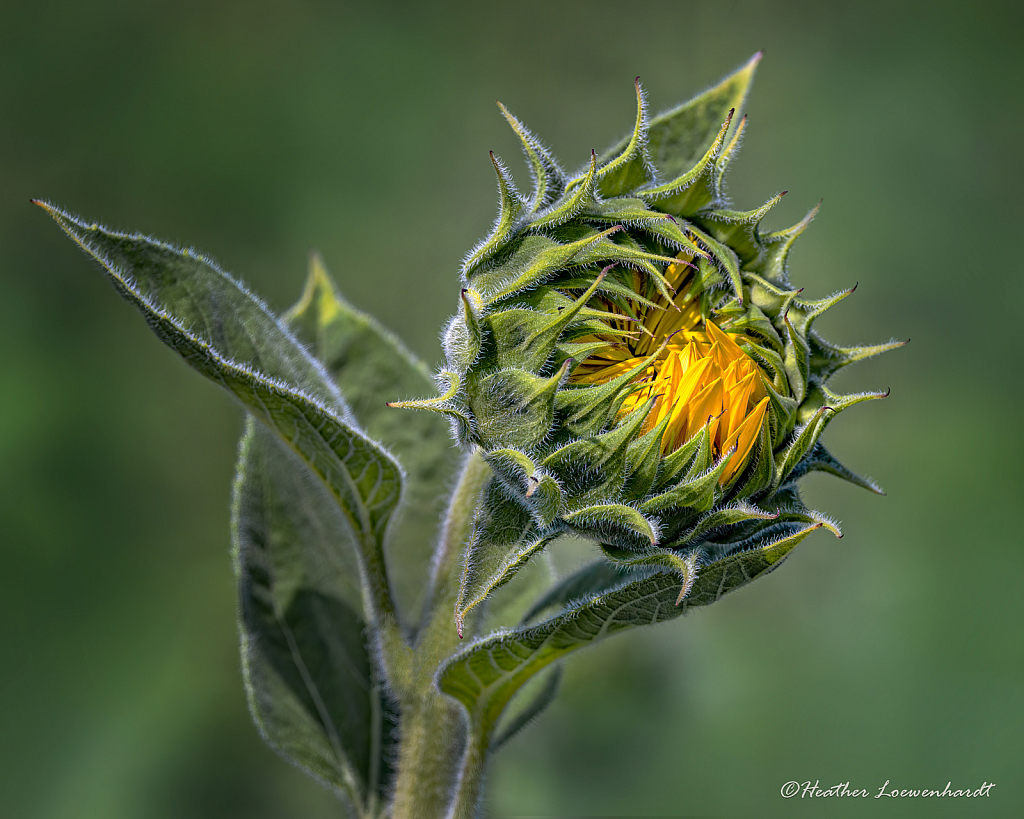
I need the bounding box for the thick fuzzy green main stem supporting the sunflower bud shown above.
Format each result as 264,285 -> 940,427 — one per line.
391,452 -> 490,819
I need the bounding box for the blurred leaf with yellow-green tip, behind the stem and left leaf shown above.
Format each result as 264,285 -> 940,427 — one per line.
285,256 -> 459,622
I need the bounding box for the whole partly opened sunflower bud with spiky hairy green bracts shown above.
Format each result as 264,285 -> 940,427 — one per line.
387,55 -> 899,594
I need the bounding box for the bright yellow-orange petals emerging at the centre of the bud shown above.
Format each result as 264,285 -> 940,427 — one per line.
571,254 -> 768,483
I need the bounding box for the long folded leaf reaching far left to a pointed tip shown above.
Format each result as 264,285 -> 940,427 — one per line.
43,205 -> 402,609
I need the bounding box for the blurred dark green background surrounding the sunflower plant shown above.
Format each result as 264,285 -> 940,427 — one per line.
0,0 -> 1024,819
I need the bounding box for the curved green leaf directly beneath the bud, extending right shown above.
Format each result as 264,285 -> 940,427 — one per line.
437,523 -> 821,736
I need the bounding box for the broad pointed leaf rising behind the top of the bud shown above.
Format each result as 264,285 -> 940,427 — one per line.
647,52 -> 761,179
